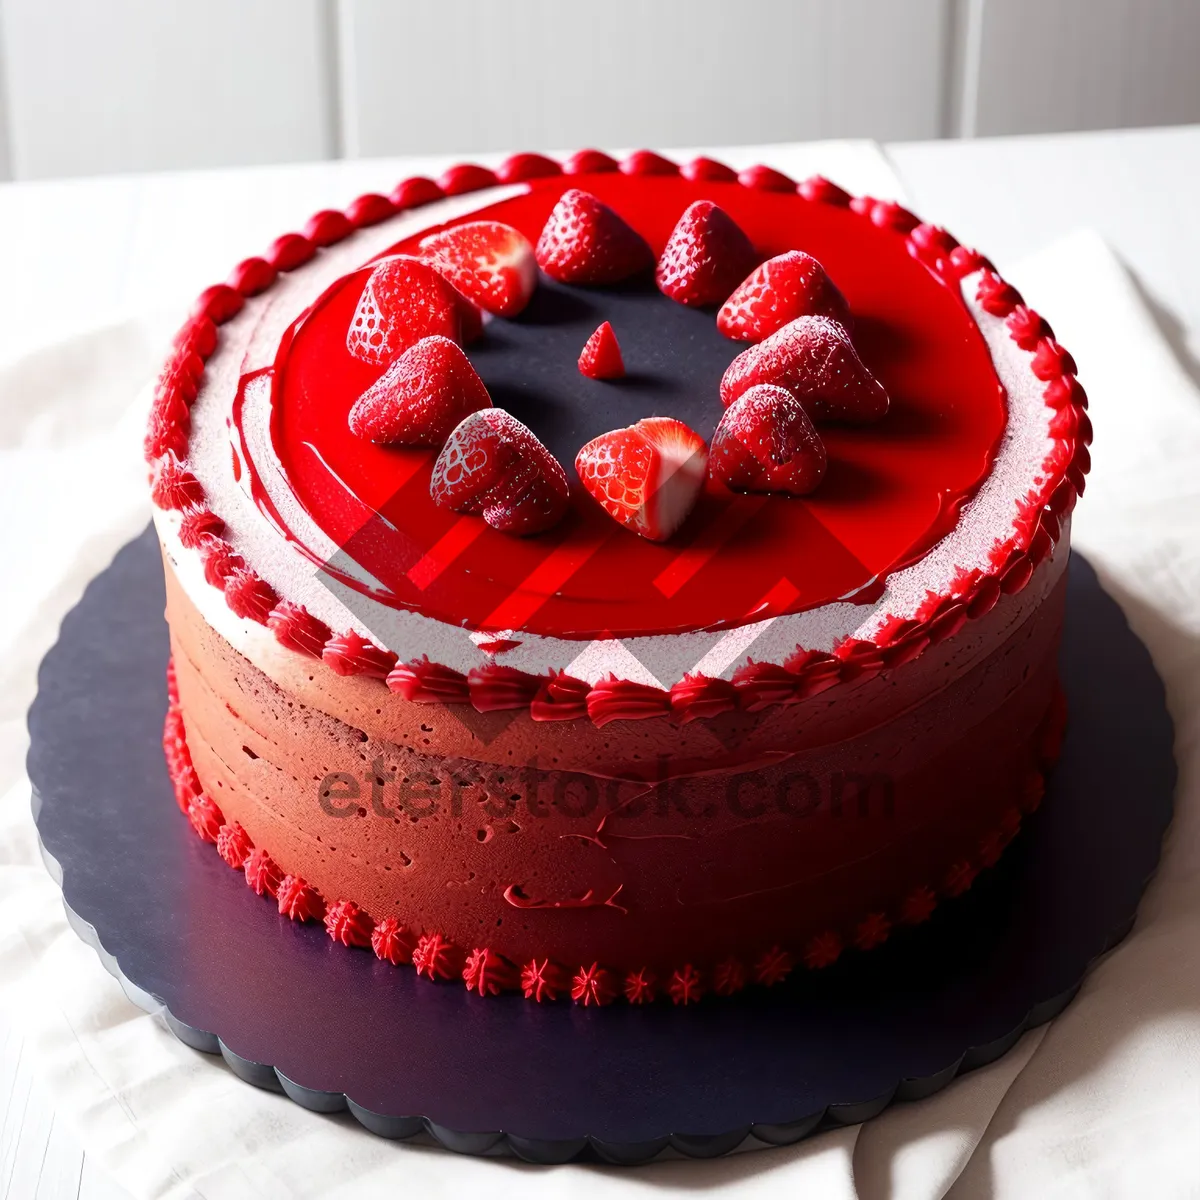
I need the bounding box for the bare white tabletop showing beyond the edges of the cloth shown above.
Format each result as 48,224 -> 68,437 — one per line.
0,126 -> 1200,1200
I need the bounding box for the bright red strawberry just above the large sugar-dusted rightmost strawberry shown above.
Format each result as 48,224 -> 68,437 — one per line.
716,250 -> 853,342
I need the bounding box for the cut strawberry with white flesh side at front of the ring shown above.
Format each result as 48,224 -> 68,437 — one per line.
575,416 -> 708,541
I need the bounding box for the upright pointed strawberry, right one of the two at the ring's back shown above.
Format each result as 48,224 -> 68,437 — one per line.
654,200 -> 758,306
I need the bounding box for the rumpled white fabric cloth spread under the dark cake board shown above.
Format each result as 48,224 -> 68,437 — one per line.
0,157 -> 1200,1200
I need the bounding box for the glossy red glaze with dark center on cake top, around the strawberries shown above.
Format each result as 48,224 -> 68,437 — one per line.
260,174 -> 1006,638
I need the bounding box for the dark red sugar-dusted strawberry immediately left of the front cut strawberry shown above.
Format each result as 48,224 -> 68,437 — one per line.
430,408 -> 569,534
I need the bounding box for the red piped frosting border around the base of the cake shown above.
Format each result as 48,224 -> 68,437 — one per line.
163,662 -> 1067,1007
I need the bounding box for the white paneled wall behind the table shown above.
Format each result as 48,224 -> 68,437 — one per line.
0,0 -> 1200,179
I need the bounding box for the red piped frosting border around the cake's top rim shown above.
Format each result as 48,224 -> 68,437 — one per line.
144,150 -> 1092,726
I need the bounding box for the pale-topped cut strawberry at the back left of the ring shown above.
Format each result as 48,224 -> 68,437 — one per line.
421,221 -> 538,317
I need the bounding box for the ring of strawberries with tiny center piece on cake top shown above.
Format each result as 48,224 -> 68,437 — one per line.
346,187 -> 888,541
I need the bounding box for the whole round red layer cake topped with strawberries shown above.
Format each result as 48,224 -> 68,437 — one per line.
146,151 -> 1091,1003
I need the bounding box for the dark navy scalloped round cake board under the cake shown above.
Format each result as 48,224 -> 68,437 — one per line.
29,529 -> 1175,1163
